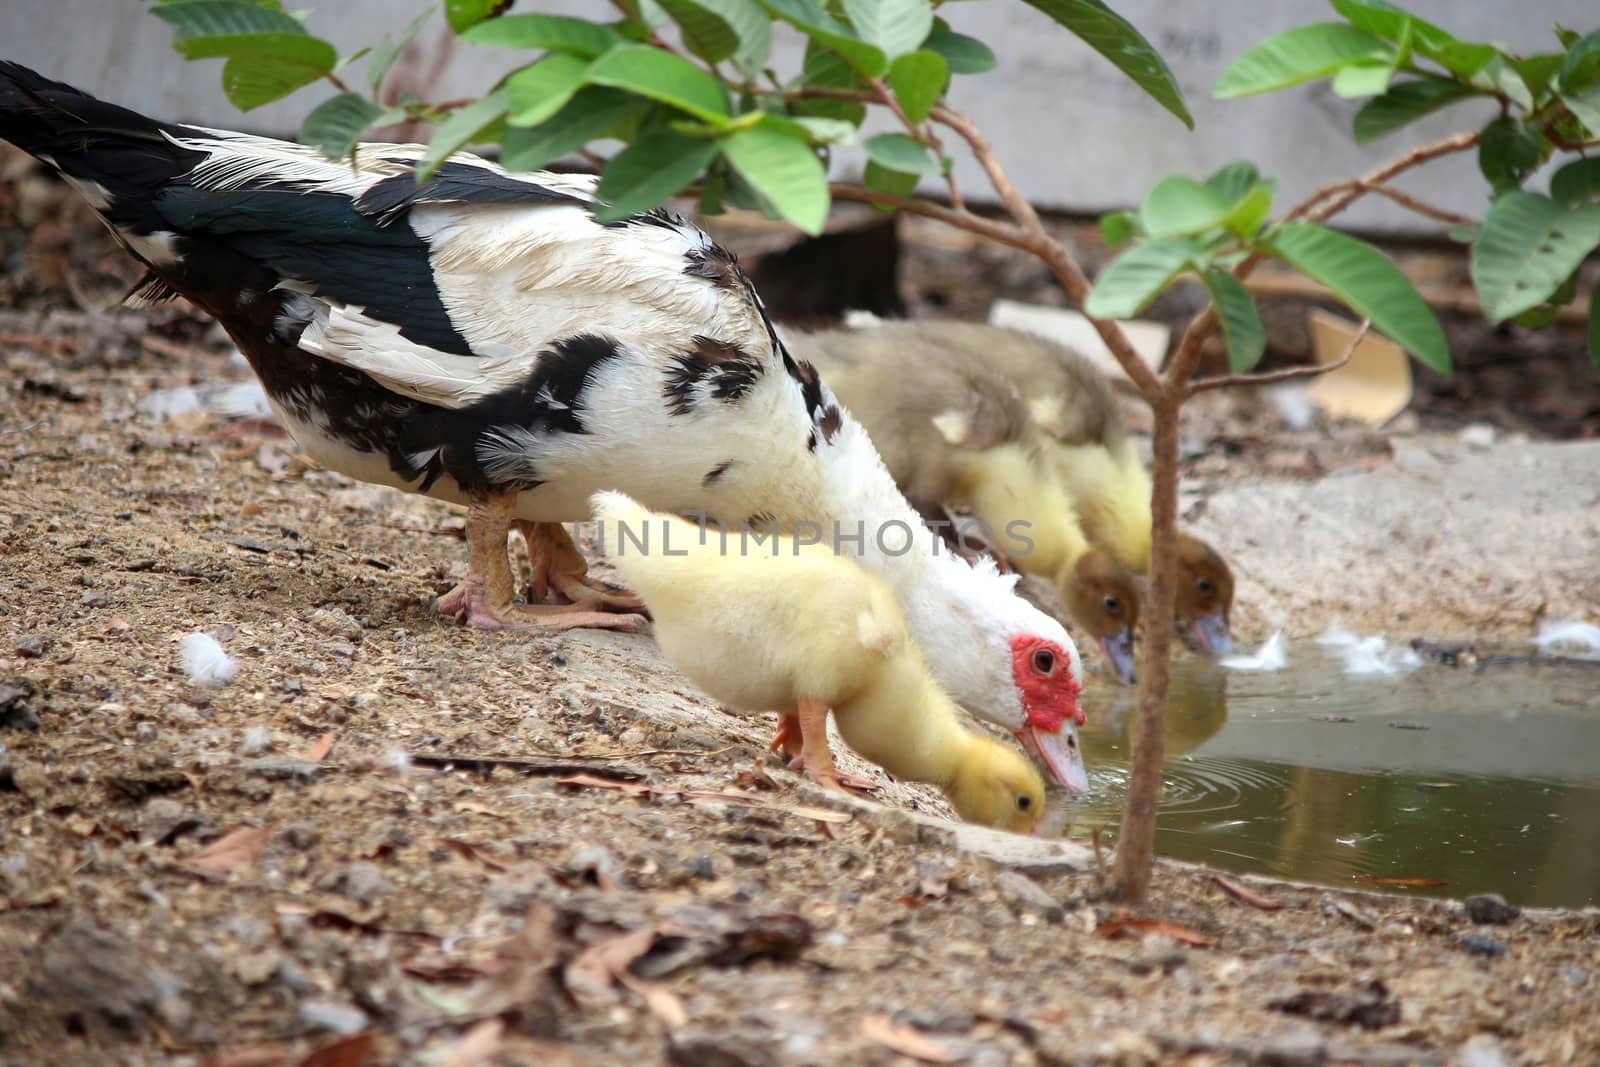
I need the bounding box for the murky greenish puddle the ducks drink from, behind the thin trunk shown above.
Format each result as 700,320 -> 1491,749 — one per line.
1058,641 -> 1600,905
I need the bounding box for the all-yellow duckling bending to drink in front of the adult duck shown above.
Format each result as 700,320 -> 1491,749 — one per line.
590,493 -> 1049,833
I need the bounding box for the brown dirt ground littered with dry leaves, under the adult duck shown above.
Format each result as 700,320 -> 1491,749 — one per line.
9,160 -> 1600,1067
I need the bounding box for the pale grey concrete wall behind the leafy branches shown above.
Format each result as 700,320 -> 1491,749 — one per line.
0,0 -> 1597,230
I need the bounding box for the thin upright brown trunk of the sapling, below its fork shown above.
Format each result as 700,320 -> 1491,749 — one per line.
1112,395 -> 1182,901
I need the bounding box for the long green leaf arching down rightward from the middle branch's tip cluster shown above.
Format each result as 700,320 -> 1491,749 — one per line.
1261,222 -> 1450,374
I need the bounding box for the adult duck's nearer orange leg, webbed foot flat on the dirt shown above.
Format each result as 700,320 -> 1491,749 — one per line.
434,493 -> 645,630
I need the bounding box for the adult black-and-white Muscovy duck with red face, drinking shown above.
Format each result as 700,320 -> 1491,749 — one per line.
0,62 -> 1086,790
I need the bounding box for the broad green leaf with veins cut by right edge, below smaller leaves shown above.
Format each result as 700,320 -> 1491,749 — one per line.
1472,190 -> 1600,322
